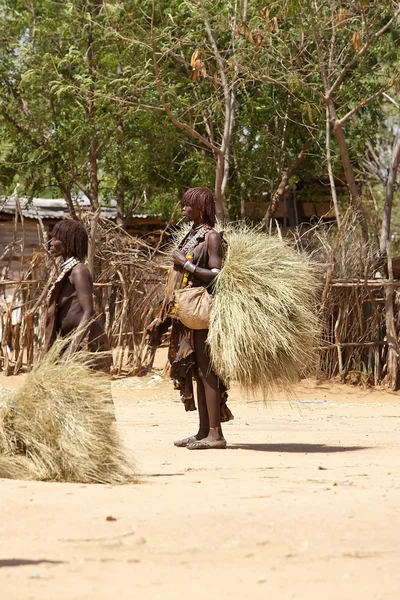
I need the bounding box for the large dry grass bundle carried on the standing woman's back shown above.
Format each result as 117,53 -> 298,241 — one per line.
208,225 -> 319,397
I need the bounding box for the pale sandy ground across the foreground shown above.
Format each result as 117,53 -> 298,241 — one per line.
0,360 -> 400,600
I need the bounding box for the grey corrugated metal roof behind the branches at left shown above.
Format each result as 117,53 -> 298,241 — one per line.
0,196 -> 155,220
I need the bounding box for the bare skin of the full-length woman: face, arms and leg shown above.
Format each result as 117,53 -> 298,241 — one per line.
172,206 -> 224,442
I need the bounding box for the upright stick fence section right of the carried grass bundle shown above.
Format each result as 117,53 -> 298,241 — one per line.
297,209 -> 400,390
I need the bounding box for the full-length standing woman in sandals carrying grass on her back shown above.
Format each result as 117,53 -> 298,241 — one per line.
151,187 -> 233,450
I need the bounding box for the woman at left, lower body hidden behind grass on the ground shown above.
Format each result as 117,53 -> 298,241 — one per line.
44,220 -> 112,373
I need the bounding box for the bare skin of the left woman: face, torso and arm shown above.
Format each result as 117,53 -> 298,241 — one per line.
49,237 -> 94,355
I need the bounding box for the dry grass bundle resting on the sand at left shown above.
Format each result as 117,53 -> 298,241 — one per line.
0,342 -> 133,483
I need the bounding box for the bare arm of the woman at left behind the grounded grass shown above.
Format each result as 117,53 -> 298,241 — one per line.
67,263 -> 94,355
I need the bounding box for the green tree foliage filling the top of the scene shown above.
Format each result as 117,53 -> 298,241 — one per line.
0,0 -> 399,225
